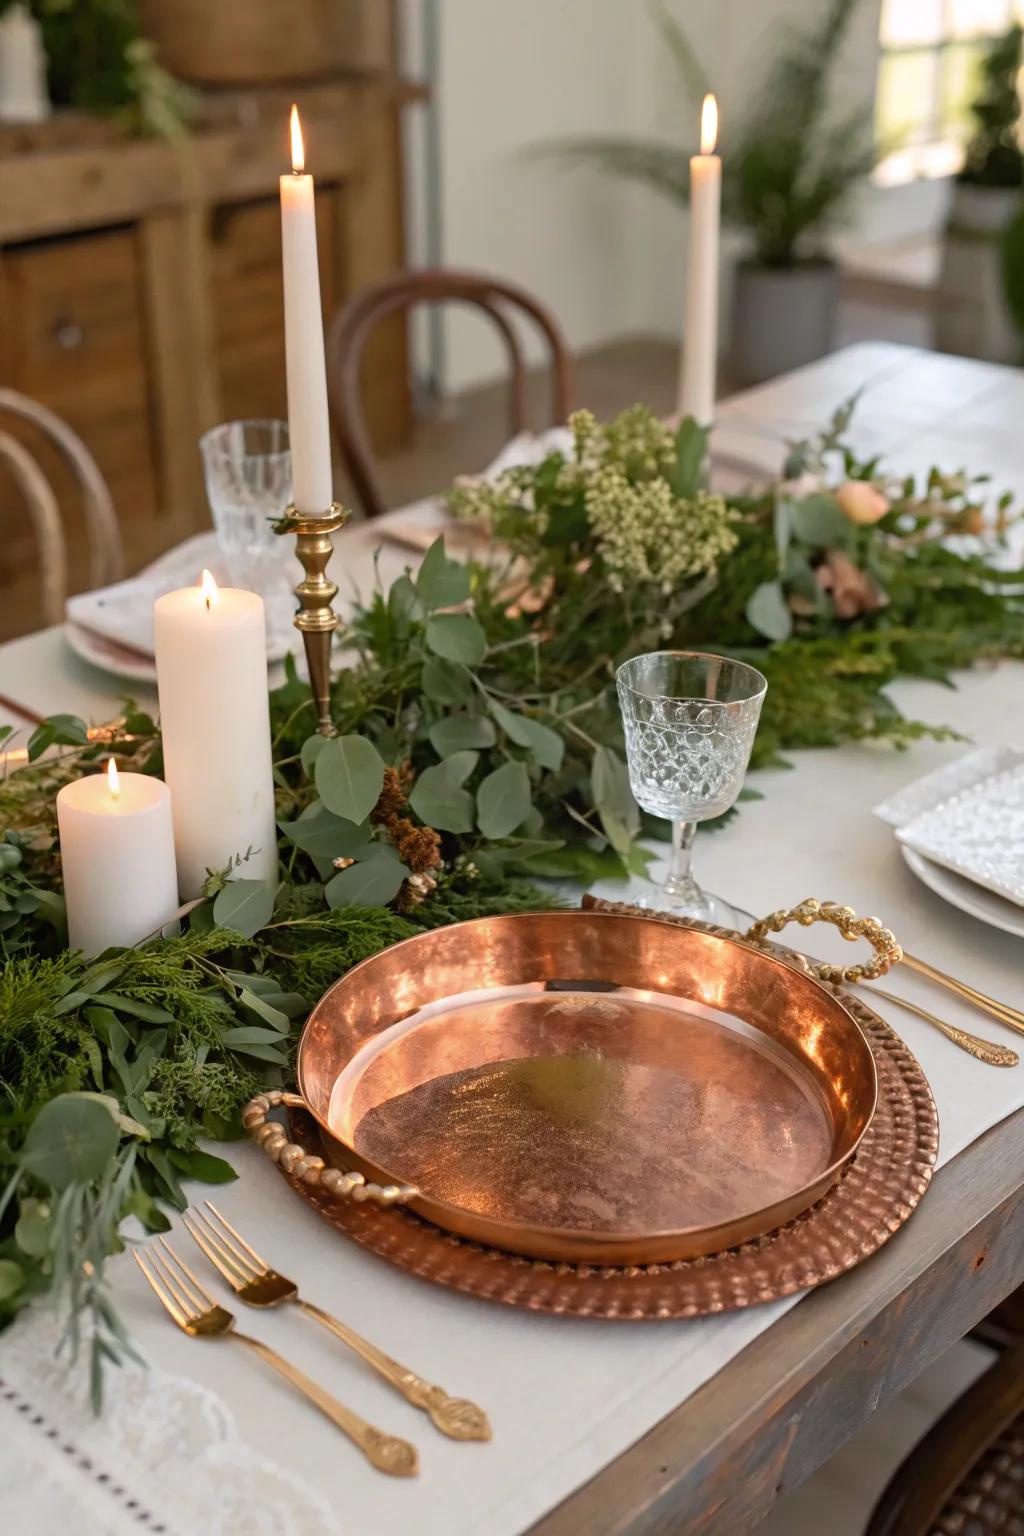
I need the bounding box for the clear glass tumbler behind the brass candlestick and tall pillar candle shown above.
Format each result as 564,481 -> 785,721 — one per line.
200,421 -> 292,598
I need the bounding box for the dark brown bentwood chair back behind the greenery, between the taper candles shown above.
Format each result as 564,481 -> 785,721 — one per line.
327,267 -> 570,518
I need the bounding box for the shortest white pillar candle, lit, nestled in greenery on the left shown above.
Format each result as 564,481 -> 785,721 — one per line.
57,759 -> 178,955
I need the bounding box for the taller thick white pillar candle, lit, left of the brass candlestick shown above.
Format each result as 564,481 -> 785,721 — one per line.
154,571 -> 278,900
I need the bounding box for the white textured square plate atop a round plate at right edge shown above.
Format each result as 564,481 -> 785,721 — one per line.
897,766 -> 1024,906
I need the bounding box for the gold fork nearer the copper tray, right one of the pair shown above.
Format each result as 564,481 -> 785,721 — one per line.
183,1200 -> 491,1441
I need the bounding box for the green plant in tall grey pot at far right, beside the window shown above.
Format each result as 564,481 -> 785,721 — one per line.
935,26 -> 1024,362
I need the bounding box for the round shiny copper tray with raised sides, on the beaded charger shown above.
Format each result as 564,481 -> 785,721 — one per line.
290,911 -> 877,1266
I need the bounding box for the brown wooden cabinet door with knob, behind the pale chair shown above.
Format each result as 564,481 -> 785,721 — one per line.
0,229 -> 164,637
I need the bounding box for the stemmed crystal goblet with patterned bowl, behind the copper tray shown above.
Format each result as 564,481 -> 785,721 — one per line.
616,651 -> 768,928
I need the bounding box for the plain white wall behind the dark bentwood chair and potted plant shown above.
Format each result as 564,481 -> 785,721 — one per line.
417,0 -> 943,390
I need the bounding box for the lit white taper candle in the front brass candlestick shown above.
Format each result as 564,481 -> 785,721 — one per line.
281,106 -> 333,515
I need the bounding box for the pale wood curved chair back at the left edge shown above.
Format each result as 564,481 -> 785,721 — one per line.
0,389 -> 124,624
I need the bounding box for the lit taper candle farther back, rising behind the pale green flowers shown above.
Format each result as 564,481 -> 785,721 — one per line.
679,95 -> 722,427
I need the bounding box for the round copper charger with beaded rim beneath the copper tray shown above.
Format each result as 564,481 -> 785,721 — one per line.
276,983 -> 938,1321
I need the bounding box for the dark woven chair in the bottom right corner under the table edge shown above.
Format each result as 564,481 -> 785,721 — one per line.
864,1289 -> 1024,1536
